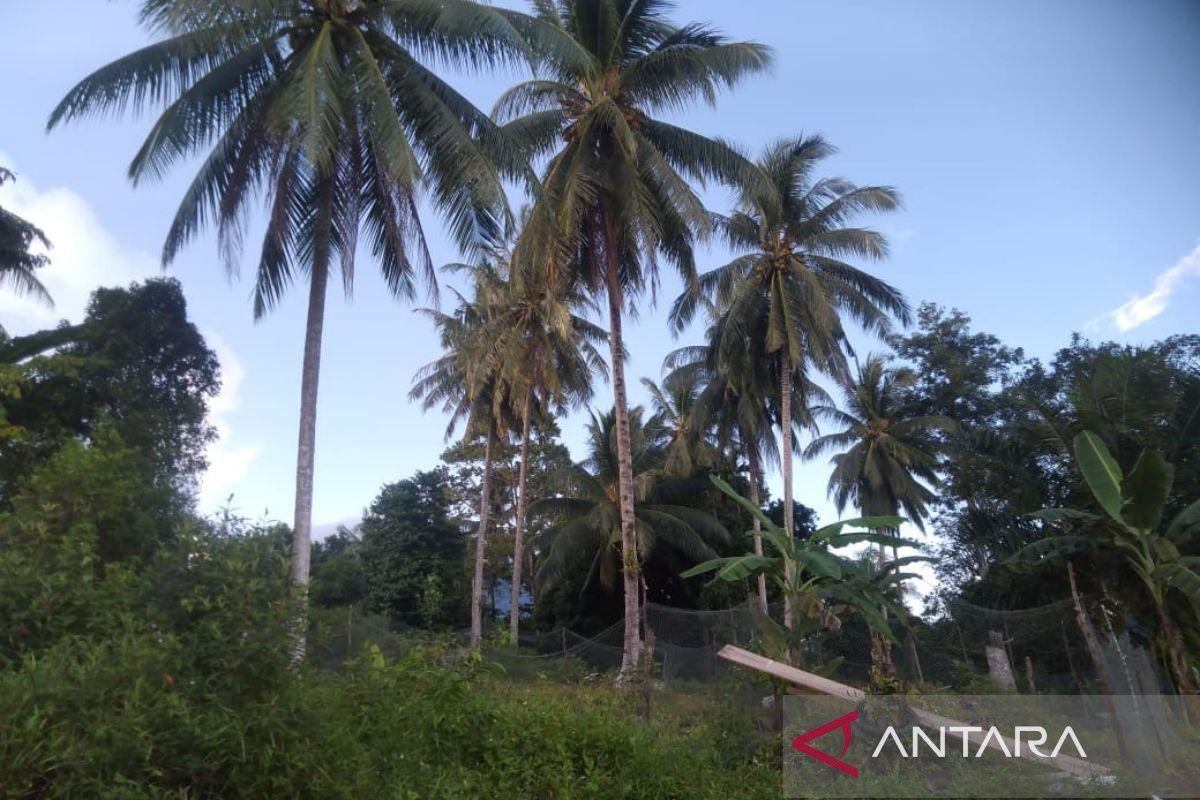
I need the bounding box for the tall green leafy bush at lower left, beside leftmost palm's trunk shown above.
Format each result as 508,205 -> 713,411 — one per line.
0,434 -> 308,798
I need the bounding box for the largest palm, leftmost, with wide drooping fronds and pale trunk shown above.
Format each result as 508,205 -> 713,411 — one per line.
48,0 -> 565,618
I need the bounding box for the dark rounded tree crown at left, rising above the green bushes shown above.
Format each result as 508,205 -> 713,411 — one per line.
0,278 -> 221,500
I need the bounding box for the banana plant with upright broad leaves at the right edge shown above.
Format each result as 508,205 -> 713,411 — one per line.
1010,431 -> 1200,693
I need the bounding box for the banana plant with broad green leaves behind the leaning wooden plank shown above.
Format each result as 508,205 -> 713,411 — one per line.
682,475 -> 929,660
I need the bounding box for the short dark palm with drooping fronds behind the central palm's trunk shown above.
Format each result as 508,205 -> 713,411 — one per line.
533,407 -> 730,606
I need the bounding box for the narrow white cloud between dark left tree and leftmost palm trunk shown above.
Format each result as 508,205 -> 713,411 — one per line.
199,331 -> 262,510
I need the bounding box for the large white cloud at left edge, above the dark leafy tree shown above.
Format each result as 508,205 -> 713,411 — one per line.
0,152 -> 158,333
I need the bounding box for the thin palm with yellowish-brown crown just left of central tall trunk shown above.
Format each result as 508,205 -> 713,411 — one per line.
463,244 -> 607,644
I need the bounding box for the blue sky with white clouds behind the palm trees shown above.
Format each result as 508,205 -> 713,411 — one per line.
0,0 -> 1200,551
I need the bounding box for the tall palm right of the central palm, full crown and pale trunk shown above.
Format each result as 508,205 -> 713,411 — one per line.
671,137 -> 911,623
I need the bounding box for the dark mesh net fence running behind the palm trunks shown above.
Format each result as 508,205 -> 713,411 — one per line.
310,599 -> 1171,694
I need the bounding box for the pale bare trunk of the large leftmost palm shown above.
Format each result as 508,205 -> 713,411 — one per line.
292,265 -> 329,664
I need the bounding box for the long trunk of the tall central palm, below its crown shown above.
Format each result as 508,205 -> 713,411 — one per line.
605,213 -> 642,679
